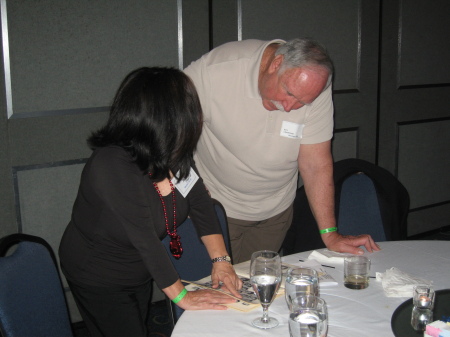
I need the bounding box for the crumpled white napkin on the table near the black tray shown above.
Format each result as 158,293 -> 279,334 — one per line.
376,267 -> 433,297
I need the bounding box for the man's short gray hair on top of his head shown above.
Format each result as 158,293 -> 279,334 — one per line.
275,38 -> 333,79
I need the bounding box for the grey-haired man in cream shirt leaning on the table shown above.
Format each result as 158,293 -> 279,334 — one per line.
185,39 -> 379,263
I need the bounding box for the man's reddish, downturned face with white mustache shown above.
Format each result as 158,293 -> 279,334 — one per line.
259,61 -> 328,112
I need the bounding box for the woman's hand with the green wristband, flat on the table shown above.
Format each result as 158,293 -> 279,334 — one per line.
177,289 -> 236,310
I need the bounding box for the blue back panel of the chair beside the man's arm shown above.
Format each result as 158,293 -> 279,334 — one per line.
338,172 -> 386,241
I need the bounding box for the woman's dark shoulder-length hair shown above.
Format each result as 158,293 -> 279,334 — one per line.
88,67 -> 203,181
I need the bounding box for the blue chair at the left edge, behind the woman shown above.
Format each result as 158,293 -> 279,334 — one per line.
0,233 -> 73,337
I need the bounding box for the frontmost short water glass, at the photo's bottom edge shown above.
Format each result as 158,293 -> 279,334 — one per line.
289,295 -> 328,337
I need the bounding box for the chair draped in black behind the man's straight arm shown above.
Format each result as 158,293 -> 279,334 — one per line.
283,158 -> 409,254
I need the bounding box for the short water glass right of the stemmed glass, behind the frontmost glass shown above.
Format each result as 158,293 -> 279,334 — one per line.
285,267 -> 319,308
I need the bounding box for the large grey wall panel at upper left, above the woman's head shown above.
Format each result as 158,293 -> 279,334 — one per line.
6,0 -> 178,118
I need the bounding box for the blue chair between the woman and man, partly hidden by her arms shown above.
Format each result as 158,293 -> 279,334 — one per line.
162,199 -> 231,325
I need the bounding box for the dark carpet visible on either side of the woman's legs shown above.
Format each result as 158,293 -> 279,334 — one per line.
72,301 -> 172,337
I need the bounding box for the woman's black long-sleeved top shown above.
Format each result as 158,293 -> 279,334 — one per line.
59,146 -> 221,289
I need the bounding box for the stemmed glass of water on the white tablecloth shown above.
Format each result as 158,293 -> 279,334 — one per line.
250,250 -> 281,329
